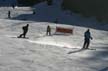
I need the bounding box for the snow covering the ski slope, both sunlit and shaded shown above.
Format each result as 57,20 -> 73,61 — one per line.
0,0 -> 108,71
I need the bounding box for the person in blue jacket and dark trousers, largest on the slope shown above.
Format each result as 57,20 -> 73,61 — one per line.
83,29 -> 93,49
